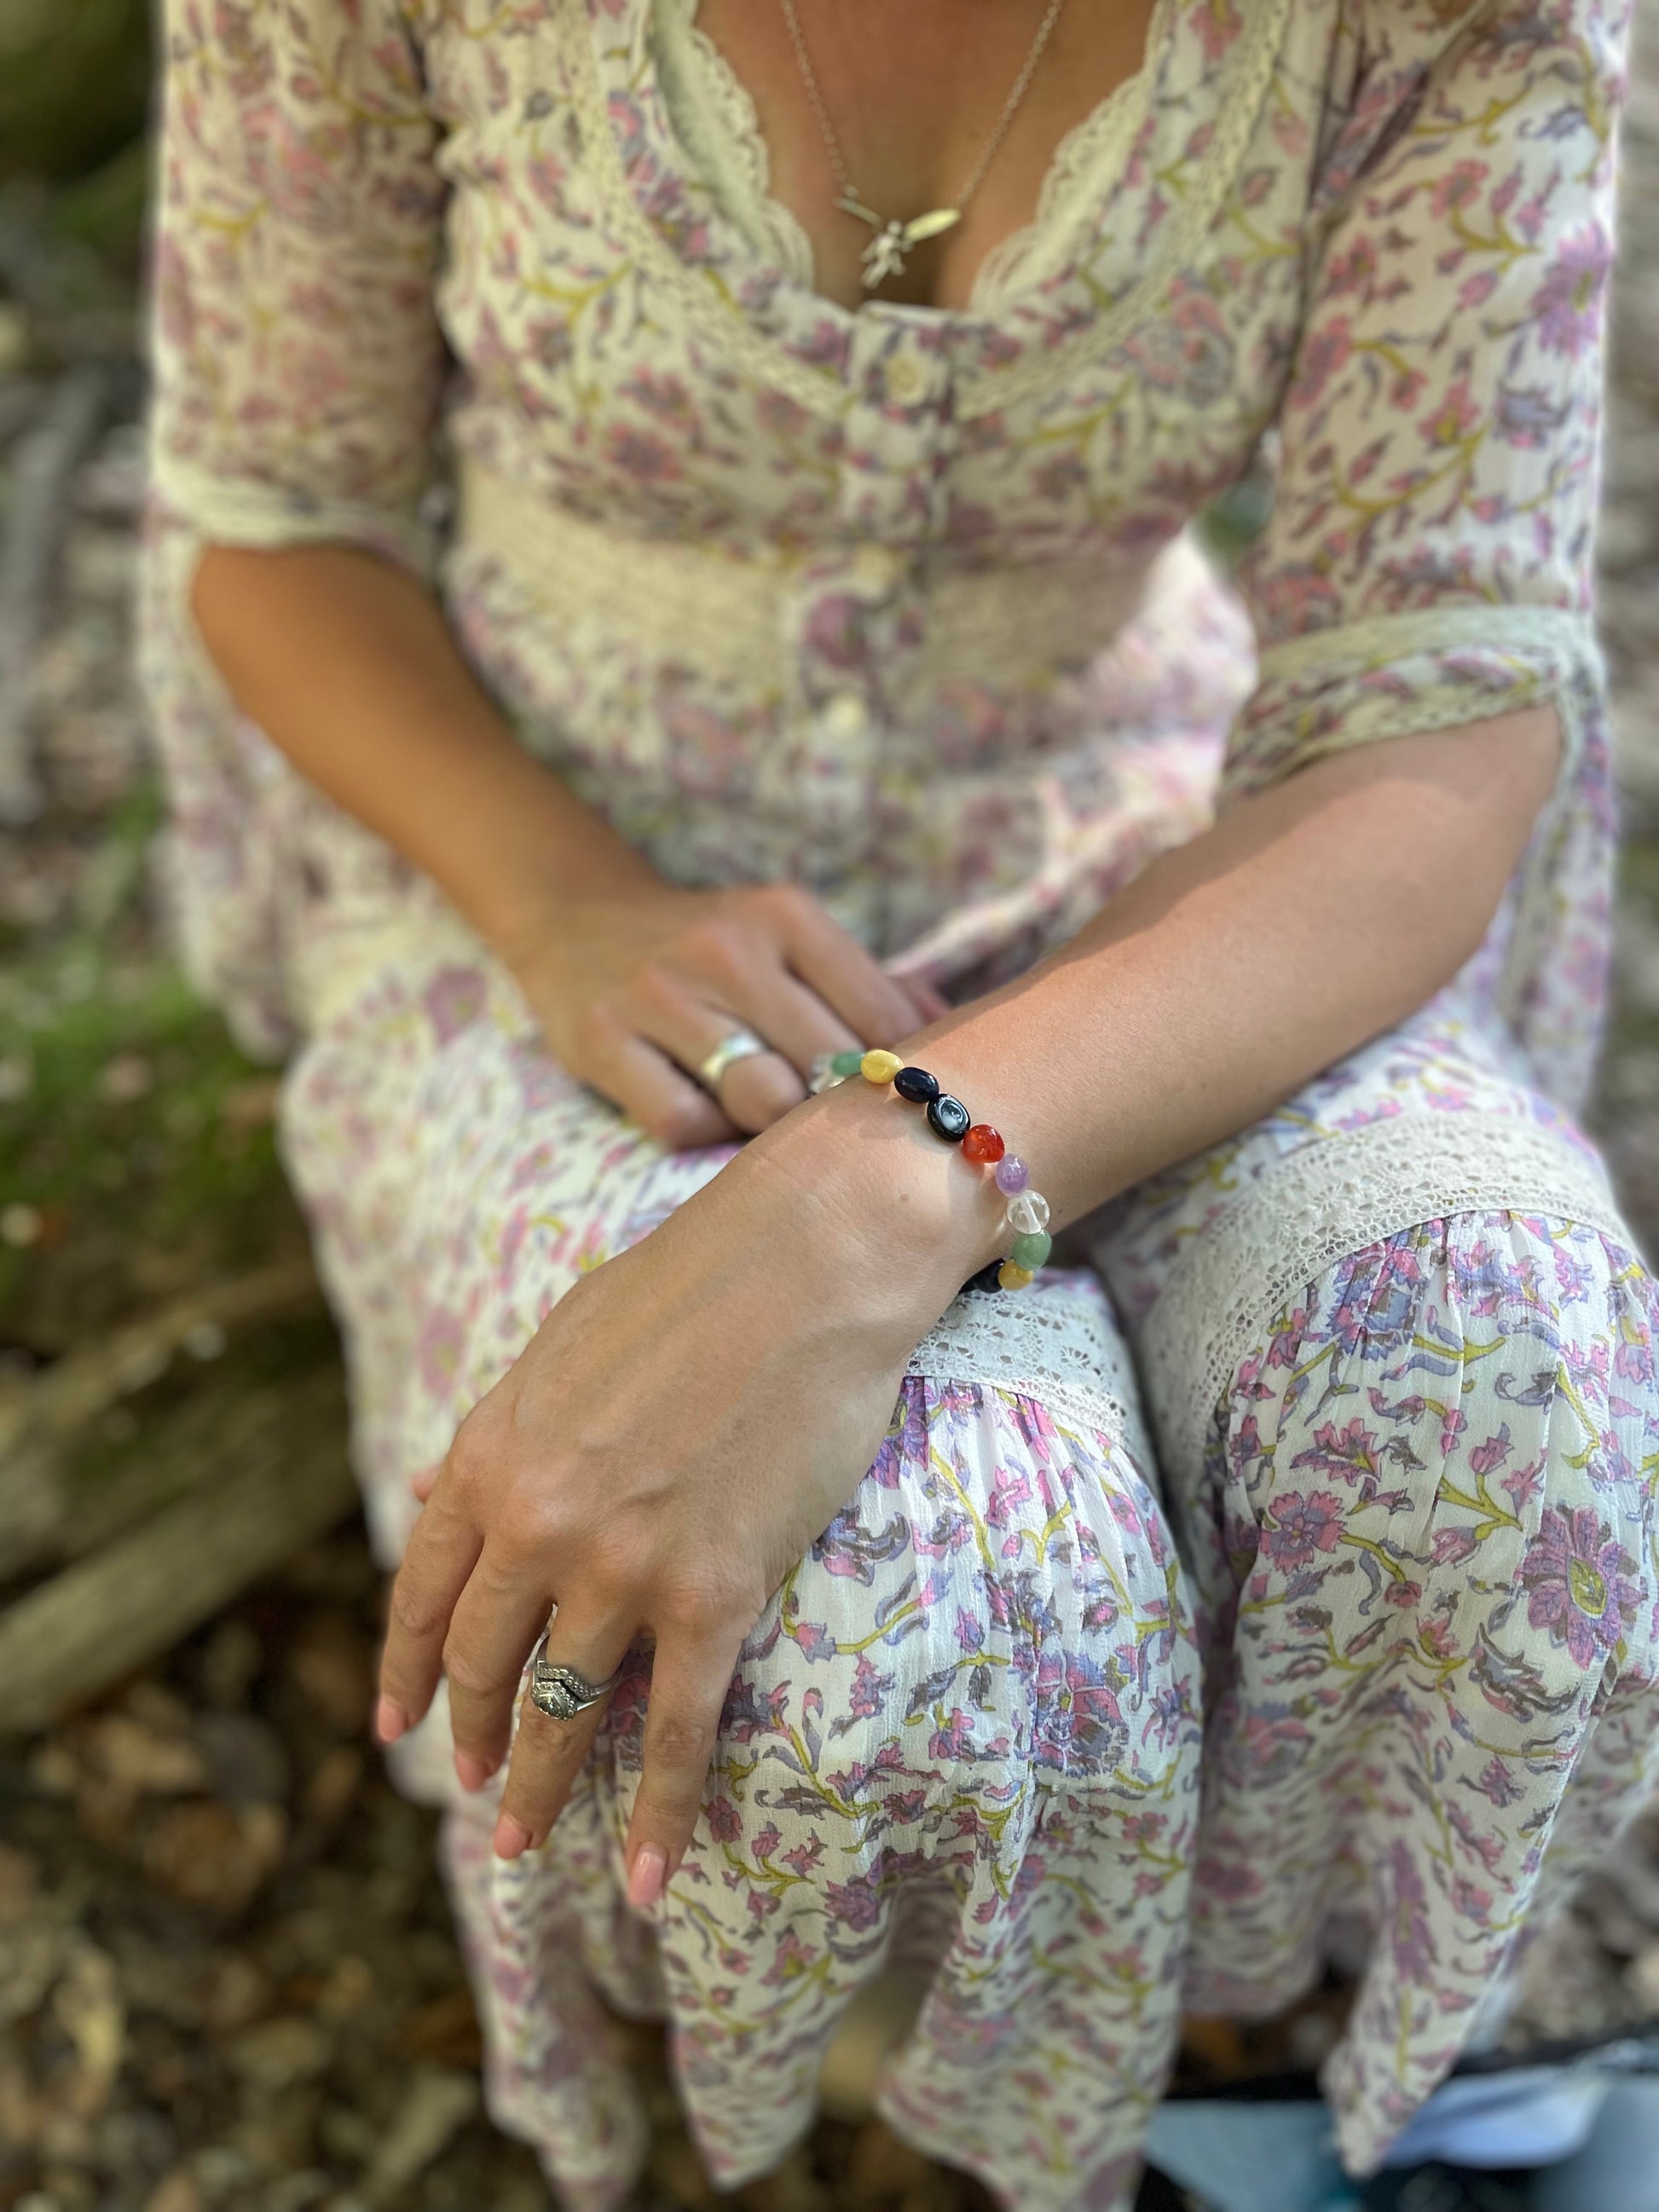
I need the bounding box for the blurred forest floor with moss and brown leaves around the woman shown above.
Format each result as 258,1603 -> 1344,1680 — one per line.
0,17 -> 1659,2212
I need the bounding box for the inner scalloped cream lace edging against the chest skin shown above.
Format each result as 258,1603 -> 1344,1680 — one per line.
650,0 -> 1175,316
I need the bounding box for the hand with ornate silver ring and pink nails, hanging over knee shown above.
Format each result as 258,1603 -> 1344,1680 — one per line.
379,1086 -> 996,1903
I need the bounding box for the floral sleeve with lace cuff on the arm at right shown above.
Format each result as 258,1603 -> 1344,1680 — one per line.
1223,0 -> 1628,799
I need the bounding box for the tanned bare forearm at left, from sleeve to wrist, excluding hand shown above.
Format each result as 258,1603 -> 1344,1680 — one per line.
193,544 -> 655,953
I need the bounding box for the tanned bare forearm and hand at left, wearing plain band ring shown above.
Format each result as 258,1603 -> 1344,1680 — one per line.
190,544 -> 945,1123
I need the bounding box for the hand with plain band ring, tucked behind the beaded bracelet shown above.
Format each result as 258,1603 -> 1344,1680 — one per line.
505,882 -> 945,1150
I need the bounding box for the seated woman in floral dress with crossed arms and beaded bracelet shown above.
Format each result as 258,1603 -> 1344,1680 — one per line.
148,0 -> 1659,2212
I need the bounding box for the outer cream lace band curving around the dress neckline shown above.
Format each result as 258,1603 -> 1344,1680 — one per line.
579,0 -> 1292,423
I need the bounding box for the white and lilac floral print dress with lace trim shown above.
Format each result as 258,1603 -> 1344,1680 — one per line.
146,0 -> 1659,2212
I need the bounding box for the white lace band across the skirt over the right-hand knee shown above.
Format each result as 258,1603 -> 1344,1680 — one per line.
1142,1112 -> 1633,1493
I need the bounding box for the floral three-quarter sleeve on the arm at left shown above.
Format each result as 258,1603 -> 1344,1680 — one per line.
150,0 -> 442,562
